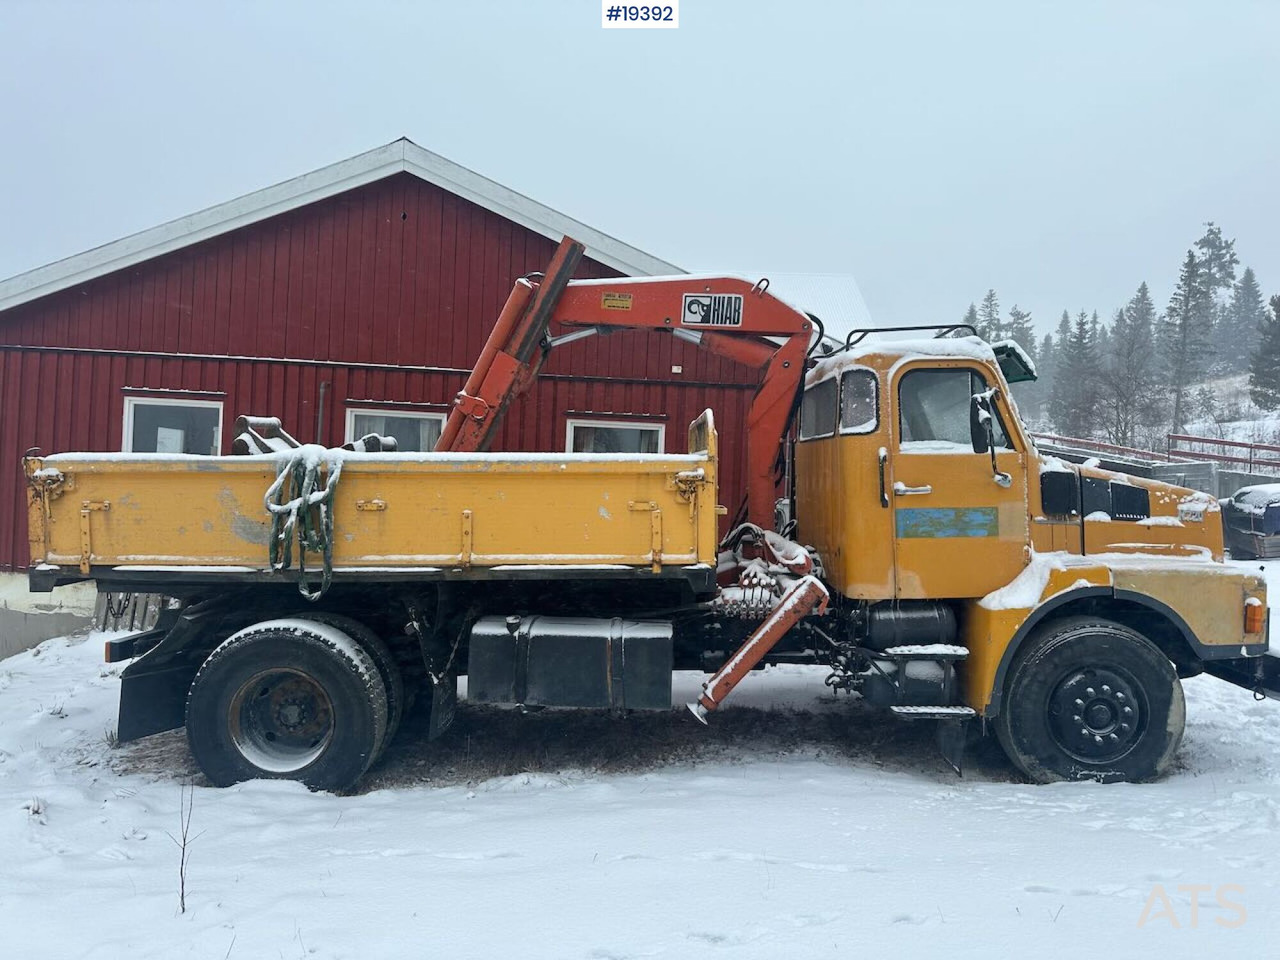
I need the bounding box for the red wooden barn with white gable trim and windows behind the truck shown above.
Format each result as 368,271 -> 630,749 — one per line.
0,140 -> 759,570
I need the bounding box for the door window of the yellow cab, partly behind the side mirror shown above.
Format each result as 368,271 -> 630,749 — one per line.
897,367 -> 1011,453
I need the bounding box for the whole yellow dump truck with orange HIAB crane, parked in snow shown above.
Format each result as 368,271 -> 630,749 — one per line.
26,241 -> 1280,788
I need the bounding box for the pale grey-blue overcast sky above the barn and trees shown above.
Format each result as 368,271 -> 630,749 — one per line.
0,0 -> 1280,337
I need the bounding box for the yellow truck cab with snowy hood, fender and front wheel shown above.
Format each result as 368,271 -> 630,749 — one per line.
792,337 -> 1277,780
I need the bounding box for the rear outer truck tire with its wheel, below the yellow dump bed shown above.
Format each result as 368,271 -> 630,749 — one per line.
187,620 -> 387,790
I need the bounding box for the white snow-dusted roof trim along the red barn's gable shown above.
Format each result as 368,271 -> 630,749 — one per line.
0,140 -> 684,311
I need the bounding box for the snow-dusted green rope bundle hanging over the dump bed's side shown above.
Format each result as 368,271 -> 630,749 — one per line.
264,444 -> 342,602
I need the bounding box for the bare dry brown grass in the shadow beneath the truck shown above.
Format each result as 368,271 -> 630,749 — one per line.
113,701 -> 1018,794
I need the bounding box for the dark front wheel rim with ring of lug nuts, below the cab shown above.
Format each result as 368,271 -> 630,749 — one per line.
1046,666 -> 1151,764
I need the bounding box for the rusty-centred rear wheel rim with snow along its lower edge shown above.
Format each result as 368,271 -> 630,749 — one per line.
228,668 -> 333,773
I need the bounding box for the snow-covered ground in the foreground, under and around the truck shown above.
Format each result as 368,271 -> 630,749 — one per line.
0,562 -> 1280,960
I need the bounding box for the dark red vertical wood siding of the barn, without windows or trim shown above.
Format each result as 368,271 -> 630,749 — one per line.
0,174 -> 758,568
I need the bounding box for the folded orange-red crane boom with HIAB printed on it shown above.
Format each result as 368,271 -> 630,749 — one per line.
435,237 -> 813,529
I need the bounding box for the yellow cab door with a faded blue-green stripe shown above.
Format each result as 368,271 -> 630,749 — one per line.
888,361 -> 1029,599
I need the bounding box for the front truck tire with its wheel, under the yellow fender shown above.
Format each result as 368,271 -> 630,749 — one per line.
995,617 -> 1187,783
